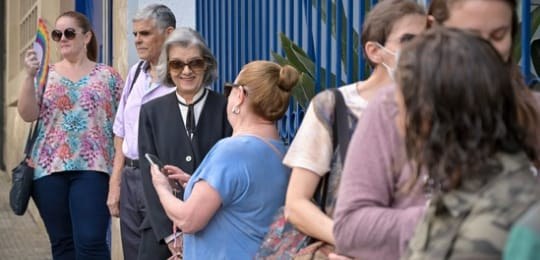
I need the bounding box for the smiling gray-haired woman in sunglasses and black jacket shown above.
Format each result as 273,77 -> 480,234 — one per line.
138,27 -> 232,259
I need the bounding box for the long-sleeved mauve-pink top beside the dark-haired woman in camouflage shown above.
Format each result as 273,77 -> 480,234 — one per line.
334,87 -> 426,260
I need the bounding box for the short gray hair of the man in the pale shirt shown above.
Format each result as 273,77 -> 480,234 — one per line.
132,4 -> 176,31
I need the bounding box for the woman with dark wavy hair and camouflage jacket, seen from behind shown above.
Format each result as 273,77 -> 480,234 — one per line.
396,28 -> 540,259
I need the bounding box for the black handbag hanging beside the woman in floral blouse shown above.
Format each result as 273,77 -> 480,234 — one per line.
9,88 -> 45,216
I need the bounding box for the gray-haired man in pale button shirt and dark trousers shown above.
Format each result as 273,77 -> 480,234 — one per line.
108,4 -> 176,259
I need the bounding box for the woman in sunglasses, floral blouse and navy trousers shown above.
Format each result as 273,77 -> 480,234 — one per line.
17,11 -> 123,259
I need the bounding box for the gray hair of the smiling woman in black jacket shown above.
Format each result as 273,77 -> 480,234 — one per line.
156,27 -> 217,87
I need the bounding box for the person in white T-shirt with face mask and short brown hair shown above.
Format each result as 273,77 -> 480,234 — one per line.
283,0 -> 426,256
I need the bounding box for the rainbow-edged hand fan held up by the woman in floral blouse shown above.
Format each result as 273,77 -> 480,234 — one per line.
34,18 -> 51,91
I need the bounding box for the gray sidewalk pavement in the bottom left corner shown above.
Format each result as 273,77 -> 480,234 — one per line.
0,171 -> 52,260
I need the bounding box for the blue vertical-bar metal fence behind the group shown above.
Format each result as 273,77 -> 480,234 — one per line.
196,0 -> 531,140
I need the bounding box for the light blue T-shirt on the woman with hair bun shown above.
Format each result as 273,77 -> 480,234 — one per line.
184,135 -> 290,260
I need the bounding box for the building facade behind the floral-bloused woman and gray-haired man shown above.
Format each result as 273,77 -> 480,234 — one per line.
0,0 -> 195,259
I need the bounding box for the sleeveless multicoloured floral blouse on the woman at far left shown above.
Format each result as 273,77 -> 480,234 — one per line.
32,64 -> 124,179
